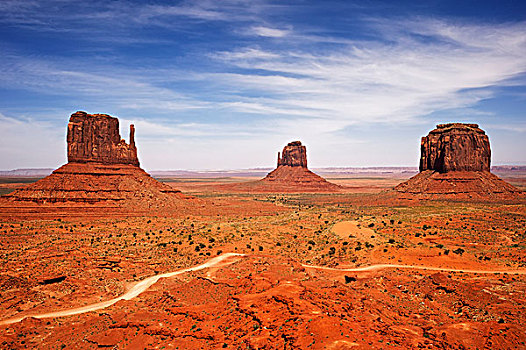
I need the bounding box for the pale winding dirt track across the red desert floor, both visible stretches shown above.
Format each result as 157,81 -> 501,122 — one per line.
0,253 -> 526,326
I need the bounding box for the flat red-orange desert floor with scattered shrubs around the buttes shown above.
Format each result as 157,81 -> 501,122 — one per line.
0,172 -> 526,349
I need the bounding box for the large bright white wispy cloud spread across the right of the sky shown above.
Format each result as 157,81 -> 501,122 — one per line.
211,20 -> 526,131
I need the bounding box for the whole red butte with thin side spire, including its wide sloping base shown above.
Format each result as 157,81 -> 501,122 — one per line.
7,112 -> 188,207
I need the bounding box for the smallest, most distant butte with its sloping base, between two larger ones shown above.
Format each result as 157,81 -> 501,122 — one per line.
260,141 -> 340,192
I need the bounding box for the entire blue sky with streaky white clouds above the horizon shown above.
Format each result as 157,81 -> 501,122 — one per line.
0,0 -> 526,170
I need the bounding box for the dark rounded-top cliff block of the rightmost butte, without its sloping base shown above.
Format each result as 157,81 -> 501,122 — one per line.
420,123 -> 491,173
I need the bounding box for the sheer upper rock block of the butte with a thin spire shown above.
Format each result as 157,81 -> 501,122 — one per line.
67,111 -> 139,166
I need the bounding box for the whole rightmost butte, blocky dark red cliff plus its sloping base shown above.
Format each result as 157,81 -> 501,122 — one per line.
394,123 -> 522,199
